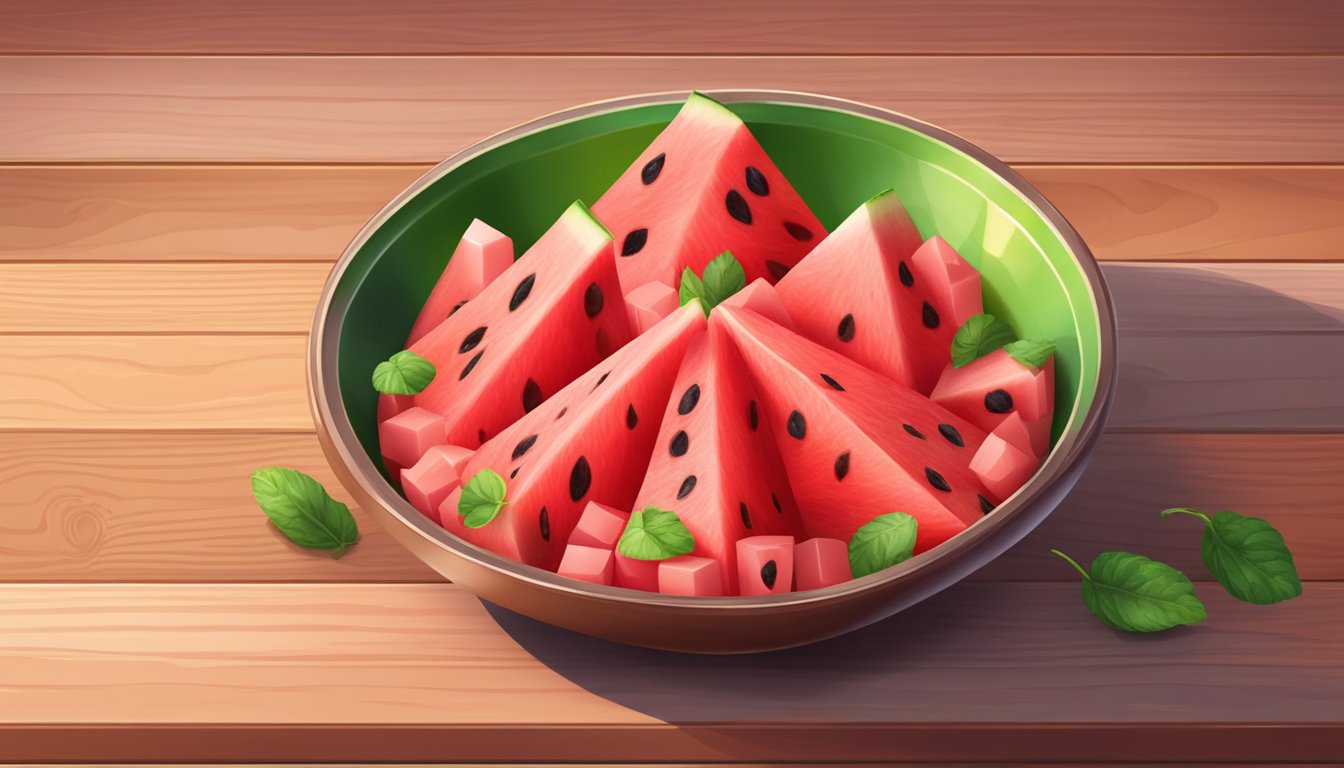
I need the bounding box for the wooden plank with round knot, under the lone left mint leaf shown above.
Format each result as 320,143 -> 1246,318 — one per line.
0,432 -> 1344,582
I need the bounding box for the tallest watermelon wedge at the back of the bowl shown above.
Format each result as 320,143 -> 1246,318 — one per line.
593,93 -> 827,292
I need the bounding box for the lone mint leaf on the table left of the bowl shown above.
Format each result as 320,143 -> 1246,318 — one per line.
251,467 -> 359,555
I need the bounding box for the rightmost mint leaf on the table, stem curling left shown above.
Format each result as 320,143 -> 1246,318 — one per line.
1163,507 -> 1302,605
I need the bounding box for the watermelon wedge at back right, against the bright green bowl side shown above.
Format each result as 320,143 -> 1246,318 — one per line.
775,190 -> 958,394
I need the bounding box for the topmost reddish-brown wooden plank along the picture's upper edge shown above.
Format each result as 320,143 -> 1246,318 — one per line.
0,0 -> 1344,55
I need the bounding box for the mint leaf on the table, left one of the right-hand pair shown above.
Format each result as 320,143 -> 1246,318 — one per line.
1050,549 -> 1208,632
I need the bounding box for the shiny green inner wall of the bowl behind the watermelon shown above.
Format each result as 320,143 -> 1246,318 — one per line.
333,102 -> 1101,476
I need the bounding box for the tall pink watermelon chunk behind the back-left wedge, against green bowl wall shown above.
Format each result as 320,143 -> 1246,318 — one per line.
406,219 -> 513,347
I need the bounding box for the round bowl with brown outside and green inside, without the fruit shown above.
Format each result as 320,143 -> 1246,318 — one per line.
308,90 -> 1117,654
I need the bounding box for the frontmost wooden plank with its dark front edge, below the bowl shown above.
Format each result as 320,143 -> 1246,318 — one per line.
0,584 -> 1344,761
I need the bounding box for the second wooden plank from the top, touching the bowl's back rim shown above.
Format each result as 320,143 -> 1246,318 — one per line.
0,56 -> 1344,163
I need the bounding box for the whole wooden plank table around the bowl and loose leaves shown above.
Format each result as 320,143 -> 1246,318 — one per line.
0,0 -> 1344,763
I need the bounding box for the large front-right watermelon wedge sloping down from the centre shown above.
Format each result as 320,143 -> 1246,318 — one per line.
711,305 -> 991,553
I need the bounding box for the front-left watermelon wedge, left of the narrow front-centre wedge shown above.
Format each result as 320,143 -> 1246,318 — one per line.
445,303 -> 704,570
